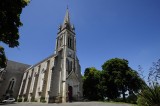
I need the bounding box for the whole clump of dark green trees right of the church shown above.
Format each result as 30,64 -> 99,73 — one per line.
83,58 -> 145,101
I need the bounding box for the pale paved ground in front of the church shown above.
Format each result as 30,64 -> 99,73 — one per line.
1,102 -> 133,106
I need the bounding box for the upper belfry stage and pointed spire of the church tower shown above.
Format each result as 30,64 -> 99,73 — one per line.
55,8 -> 76,54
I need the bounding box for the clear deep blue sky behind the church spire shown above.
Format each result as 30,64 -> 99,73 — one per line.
0,0 -> 160,76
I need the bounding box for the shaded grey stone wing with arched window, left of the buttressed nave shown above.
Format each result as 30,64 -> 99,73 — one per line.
0,60 -> 30,99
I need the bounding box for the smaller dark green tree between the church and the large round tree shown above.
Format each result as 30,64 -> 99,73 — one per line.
83,67 -> 103,100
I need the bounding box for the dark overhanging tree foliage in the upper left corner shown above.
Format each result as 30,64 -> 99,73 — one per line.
0,0 -> 29,67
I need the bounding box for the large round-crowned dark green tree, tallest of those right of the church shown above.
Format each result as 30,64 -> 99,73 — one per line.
102,58 -> 143,101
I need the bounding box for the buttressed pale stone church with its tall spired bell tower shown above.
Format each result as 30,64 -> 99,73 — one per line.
0,9 -> 82,103
